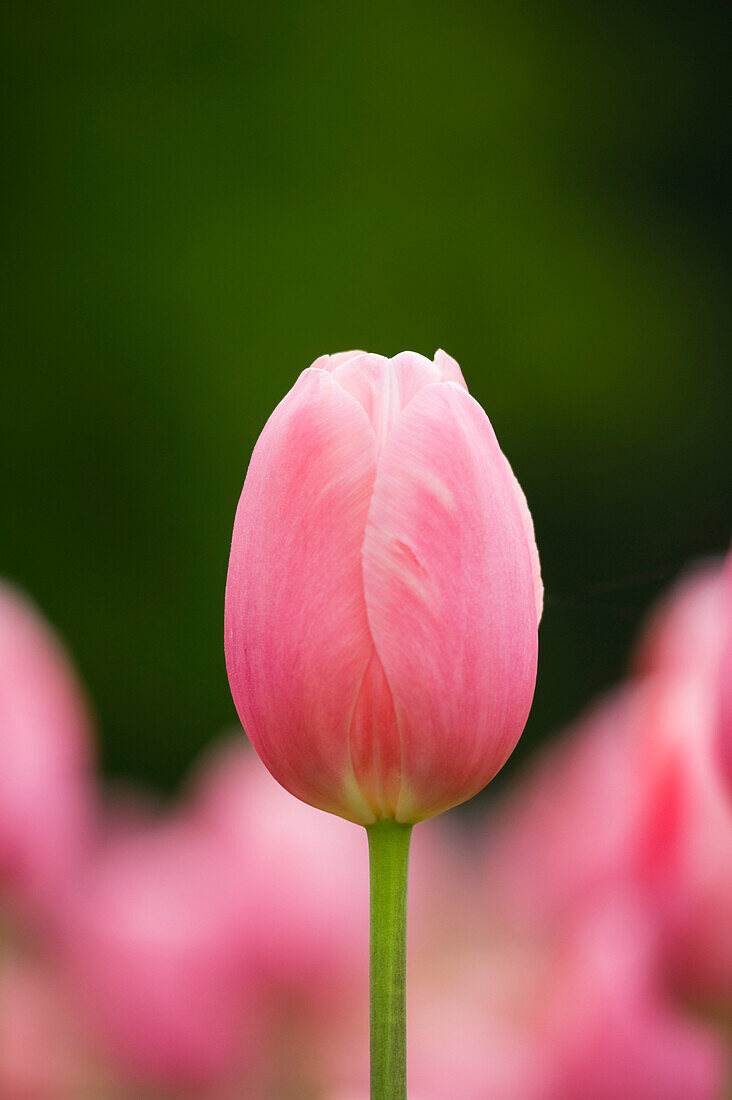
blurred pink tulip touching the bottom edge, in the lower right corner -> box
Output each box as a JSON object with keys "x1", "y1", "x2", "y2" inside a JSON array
[{"x1": 538, "y1": 898, "x2": 728, "y2": 1100}]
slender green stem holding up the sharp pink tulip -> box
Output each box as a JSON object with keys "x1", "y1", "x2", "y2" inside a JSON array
[{"x1": 367, "y1": 821, "x2": 412, "y2": 1100}]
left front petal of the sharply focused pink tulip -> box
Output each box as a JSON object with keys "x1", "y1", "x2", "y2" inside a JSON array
[{"x1": 226, "y1": 370, "x2": 376, "y2": 824}]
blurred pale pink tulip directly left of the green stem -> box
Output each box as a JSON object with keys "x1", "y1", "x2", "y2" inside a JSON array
[{"x1": 189, "y1": 734, "x2": 369, "y2": 1011}]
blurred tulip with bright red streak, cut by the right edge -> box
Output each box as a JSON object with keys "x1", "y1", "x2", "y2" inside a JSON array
[{"x1": 636, "y1": 675, "x2": 732, "y2": 1003}]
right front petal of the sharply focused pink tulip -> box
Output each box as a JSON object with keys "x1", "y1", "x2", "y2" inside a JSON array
[{"x1": 363, "y1": 383, "x2": 537, "y2": 821}]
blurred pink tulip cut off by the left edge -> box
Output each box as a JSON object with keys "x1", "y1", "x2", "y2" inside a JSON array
[{"x1": 0, "y1": 585, "x2": 92, "y2": 912}]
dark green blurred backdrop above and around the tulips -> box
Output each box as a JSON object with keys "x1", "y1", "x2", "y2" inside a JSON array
[{"x1": 0, "y1": 0, "x2": 732, "y2": 788}]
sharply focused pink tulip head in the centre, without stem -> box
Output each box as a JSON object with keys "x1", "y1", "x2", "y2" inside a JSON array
[{"x1": 226, "y1": 352, "x2": 542, "y2": 824}]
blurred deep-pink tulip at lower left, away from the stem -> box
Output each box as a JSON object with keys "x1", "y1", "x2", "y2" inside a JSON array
[{"x1": 64, "y1": 816, "x2": 255, "y2": 1090}]
